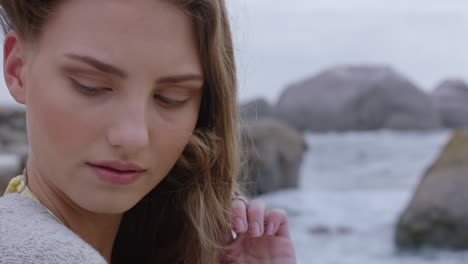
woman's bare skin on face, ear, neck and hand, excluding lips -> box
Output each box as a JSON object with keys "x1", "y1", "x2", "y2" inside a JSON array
[{"x1": 4, "y1": 0, "x2": 295, "y2": 264}]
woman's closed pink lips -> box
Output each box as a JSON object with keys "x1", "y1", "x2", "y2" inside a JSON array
[{"x1": 88, "y1": 163, "x2": 144, "y2": 185}]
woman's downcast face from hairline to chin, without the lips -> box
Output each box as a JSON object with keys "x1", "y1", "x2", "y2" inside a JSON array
[{"x1": 12, "y1": 0, "x2": 203, "y2": 213}]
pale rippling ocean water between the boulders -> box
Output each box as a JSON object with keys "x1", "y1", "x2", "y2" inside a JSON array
[{"x1": 263, "y1": 131, "x2": 468, "y2": 264}]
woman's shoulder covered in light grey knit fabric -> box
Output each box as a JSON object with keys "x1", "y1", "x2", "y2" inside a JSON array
[{"x1": 0, "y1": 194, "x2": 106, "y2": 264}]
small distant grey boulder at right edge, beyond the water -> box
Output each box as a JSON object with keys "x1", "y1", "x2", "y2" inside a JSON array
[{"x1": 431, "y1": 79, "x2": 468, "y2": 128}]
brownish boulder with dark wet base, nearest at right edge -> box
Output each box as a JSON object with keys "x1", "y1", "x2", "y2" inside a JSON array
[{"x1": 395, "y1": 130, "x2": 468, "y2": 249}]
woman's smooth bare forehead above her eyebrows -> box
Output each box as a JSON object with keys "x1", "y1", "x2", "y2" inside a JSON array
[{"x1": 33, "y1": 0, "x2": 200, "y2": 76}]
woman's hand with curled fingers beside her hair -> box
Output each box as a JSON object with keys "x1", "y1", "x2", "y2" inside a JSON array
[{"x1": 221, "y1": 199, "x2": 296, "y2": 264}]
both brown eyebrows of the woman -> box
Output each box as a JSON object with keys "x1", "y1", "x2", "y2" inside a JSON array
[{"x1": 65, "y1": 53, "x2": 204, "y2": 83}]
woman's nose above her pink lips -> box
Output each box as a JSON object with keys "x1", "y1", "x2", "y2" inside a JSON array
[{"x1": 108, "y1": 104, "x2": 149, "y2": 154}]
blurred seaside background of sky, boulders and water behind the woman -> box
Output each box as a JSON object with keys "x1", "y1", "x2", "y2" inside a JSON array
[{"x1": 0, "y1": 0, "x2": 468, "y2": 264}]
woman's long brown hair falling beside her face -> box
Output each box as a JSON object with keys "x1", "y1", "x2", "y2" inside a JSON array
[{"x1": 0, "y1": 0, "x2": 239, "y2": 264}]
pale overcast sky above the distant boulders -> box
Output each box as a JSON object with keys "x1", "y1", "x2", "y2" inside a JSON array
[{"x1": 0, "y1": 0, "x2": 468, "y2": 102}]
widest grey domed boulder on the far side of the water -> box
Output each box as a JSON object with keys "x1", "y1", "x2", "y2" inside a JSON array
[{"x1": 277, "y1": 66, "x2": 441, "y2": 131}]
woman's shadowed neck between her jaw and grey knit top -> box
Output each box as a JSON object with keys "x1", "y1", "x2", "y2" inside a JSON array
[{"x1": 27, "y1": 162, "x2": 123, "y2": 263}]
